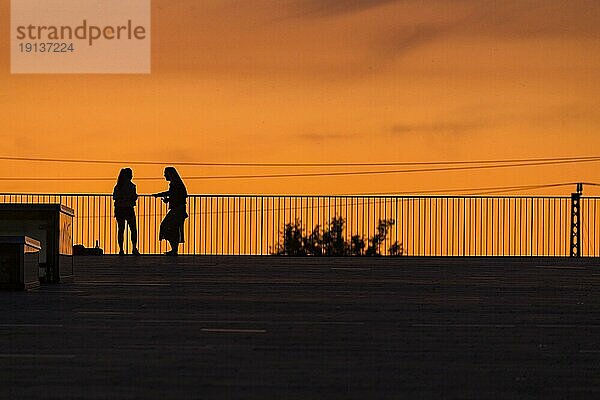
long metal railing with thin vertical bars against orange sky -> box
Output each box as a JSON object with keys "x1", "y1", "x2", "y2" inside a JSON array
[{"x1": 0, "y1": 193, "x2": 600, "y2": 257}]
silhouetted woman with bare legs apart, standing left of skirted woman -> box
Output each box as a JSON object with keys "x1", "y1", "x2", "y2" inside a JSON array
[{"x1": 113, "y1": 168, "x2": 140, "y2": 256}]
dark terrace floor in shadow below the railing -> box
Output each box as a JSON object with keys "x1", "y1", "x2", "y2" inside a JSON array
[{"x1": 0, "y1": 256, "x2": 600, "y2": 399}]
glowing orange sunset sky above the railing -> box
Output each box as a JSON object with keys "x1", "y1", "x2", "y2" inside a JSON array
[{"x1": 0, "y1": 0, "x2": 600, "y2": 194}]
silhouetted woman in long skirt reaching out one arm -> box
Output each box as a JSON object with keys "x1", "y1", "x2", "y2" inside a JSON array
[{"x1": 153, "y1": 167, "x2": 188, "y2": 256}]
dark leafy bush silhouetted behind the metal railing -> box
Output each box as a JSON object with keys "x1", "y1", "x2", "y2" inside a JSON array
[{"x1": 275, "y1": 217, "x2": 403, "y2": 257}]
